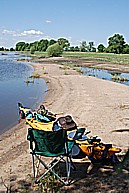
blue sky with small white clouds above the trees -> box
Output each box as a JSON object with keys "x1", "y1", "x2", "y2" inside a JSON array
[{"x1": 0, "y1": 0, "x2": 129, "y2": 48}]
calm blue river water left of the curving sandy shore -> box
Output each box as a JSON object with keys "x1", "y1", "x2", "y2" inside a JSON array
[{"x1": 0, "y1": 53, "x2": 47, "y2": 134}]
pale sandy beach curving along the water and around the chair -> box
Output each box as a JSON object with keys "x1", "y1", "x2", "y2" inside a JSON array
[{"x1": 0, "y1": 58, "x2": 129, "y2": 192}]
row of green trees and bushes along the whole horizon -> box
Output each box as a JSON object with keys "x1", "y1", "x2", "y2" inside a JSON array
[{"x1": 0, "y1": 34, "x2": 129, "y2": 56}]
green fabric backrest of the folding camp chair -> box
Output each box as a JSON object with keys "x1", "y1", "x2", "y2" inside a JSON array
[{"x1": 28, "y1": 128, "x2": 67, "y2": 156}]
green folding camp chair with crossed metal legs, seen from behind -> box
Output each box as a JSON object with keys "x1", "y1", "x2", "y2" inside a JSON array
[{"x1": 27, "y1": 128, "x2": 75, "y2": 185}]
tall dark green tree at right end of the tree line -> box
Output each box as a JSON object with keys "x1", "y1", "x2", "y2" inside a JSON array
[{"x1": 106, "y1": 34, "x2": 125, "y2": 54}]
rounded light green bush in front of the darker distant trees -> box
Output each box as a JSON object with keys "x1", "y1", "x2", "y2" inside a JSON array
[{"x1": 46, "y1": 43, "x2": 63, "y2": 57}]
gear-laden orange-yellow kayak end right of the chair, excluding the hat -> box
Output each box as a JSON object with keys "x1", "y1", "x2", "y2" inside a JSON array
[{"x1": 68, "y1": 128, "x2": 121, "y2": 165}]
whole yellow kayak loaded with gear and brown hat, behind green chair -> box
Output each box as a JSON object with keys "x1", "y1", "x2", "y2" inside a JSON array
[{"x1": 18, "y1": 103, "x2": 121, "y2": 164}]
